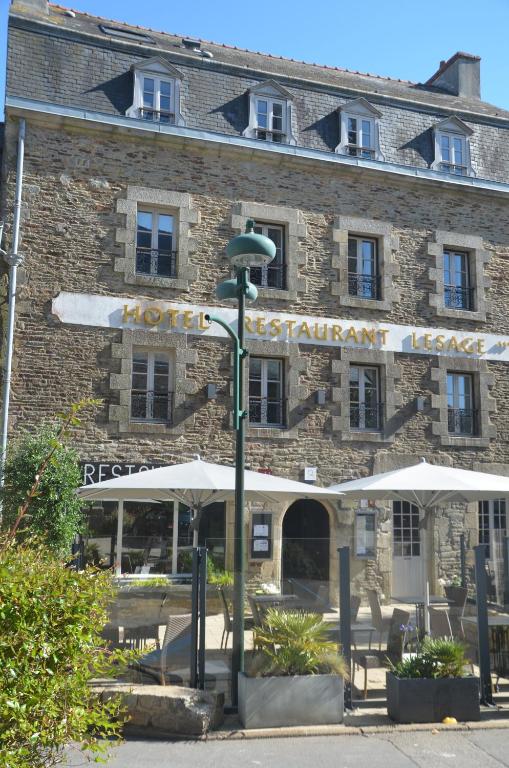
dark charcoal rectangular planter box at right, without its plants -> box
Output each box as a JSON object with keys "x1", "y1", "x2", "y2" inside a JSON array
[{"x1": 387, "y1": 672, "x2": 481, "y2": 723}]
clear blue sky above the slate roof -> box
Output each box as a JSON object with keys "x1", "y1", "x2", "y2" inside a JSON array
[{"x1": 0, "y1": 0, "x2": 509, "y2": 109}]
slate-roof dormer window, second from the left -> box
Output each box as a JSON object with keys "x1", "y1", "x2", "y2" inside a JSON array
[{"x1": 244, "y1": 80, "x2": 296, "y2": 144}]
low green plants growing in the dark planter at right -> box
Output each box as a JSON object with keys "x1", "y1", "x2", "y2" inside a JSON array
[{"x1": 392, "y1": 637, "x2": 468, "y2": 679}]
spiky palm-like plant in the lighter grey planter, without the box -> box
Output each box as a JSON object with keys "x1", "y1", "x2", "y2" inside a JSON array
[{"x1": 251, "y1": 608, "x2": 347, "y2": 677}]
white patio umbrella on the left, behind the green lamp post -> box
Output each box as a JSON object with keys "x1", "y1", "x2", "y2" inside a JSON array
[{"x1": 77, "y1": 459, "x2": 340, "y2": 570}]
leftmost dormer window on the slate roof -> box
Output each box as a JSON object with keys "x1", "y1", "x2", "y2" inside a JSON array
[{"x1": 126, "y1": 58, "x2": 185, "y2": 125}]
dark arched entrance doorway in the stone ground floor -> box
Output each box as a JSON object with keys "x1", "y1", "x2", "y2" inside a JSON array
[{"x1": 281, "y1": 499, "x2": 330, "y2": 596}]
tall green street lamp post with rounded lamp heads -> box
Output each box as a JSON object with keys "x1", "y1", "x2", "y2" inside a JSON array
[{"x1": 205, "y1": 220, "x2": 276, "y2": 707}]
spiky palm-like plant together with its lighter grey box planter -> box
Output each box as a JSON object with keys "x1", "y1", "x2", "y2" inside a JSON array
[{"x1": 238, "y1": 608, "x2": 347, "y2": 728}]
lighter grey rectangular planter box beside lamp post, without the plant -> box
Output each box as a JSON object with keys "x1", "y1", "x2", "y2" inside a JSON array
[{"x1": 239, "y1": 673, "x2": 344, "y2": 728}]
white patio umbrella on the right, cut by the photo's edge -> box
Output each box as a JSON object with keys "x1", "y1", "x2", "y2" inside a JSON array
[{"x1": 329, "y1": 459, "x2": 509, "y2": 630}]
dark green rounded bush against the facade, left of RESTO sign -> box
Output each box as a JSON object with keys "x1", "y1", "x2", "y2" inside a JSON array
[{"x1": 0, "y1": 423, "x2": 82, "y2": 554}]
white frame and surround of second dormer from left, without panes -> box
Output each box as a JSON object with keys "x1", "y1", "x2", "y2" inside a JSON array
[{"x1": 243, "y1": 80, "x2": 297, "y2": 145}]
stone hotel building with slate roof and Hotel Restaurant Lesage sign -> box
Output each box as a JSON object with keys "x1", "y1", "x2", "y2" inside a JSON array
[{"x1": 2, "y1": 0, "x2": 509, "y2": 596}]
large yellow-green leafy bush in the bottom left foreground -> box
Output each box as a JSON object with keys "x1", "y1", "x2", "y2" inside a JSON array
[{"x1": 0, "y1": 541, "x2": 131, "y2": 768}]
